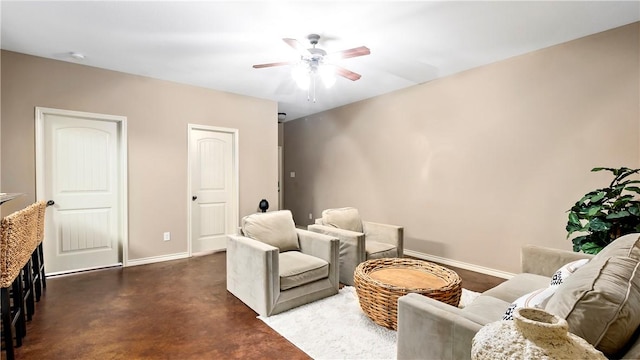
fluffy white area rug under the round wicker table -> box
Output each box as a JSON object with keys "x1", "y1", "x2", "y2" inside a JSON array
[{"x1": 258, "y1": 286, "x2": 479, "y2": 360}]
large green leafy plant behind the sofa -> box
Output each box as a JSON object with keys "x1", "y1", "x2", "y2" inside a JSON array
[{"x1": 566, "y1": 167, "x2": 640, "y2": 254}]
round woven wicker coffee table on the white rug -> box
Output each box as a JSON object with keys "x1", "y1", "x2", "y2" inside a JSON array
[{"x1": 354, "y1": 258, "x2": 462, "y2": 330}]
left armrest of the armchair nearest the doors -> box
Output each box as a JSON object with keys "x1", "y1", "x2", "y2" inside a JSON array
[{"x1": 227, "y1": 235, "x2": 280, "y2": 315}]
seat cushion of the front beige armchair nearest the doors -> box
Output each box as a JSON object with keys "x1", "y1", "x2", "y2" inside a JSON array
[{"x1": 278, "y1": 251, "x2": 329, "y2": 290}]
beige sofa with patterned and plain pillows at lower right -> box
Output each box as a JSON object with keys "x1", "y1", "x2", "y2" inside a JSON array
[{"x1": 397, "y1": 234, "x2": 640, "y2": 360}]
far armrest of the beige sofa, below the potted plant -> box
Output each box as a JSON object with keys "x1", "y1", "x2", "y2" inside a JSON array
[{"x1": 520, "y1": 245, "x2": 593, "y2": 277}]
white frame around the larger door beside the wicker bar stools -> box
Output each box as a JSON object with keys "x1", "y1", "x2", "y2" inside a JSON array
[{"x1": 35, "y1": 106, "x2": 129, "y2": 267}]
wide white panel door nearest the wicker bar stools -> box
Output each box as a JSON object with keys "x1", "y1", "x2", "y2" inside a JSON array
[{"x1": 38, "y1": 113, "x2": 122, "y2": 273}]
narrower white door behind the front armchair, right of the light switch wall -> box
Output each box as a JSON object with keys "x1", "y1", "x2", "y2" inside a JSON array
[{"x1": 189, "y1": 129, "x2": 237, "y2": 253}]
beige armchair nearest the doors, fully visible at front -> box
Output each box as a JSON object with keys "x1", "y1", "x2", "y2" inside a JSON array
[{"x1": 227, "y1": 210, "x2": 339, "y2": 316}]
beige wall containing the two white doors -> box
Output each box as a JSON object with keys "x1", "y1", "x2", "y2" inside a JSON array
[{"x1": 1, "y1": 51, "x2": 278, "y2": 259}]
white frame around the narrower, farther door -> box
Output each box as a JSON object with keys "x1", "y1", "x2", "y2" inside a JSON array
[{"x1": 187, "y1": 124, "x2": 240, "y2": 257}]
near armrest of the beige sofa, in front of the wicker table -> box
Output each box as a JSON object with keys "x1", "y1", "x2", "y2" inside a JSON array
[{"x1": 397, "y1": 294, "x2": 484, "y2": 360}]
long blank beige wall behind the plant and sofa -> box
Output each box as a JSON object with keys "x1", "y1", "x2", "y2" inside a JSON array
[{"x1": 284, "y1": 23, "x2": 640, "y2": 272}]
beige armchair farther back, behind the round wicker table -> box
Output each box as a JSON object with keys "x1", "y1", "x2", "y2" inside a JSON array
[{"x1": 307, "y1": 207, "x2": 404, "y2": 285}]
